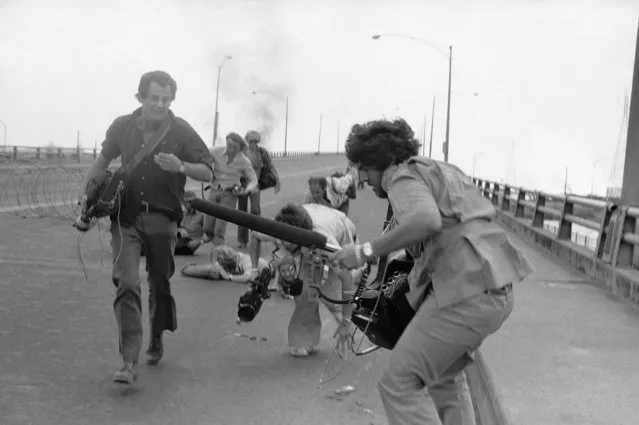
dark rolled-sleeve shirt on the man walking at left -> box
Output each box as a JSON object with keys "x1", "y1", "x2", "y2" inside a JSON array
[{"x1": 101, "y1": 108, "x2": 212, "y2": 225}]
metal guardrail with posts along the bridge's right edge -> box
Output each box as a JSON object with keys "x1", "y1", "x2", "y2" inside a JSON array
[{"x1": 473, "y1": 178, "x2": 639, "y2": 269}]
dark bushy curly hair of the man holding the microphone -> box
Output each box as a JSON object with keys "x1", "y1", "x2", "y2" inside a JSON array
[{"x1": 346, "y1": 118, "x2": 421, "y2": 170}]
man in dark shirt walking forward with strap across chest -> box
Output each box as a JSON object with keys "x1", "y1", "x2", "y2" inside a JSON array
[{"x1": 77, "y1": 71, "x2": 213, "y2": 384}]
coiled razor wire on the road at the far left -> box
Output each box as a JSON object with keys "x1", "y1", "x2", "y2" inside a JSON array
[{"x1": 0, "y1": 165, "x2": 88, "y2": 220}]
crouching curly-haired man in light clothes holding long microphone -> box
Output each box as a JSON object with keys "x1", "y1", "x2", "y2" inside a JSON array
[{"x1": 334, "y1": 119, "x2": 532, "y2": 425}]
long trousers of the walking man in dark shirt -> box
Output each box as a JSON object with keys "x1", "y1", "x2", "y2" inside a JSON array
[{"x1": 111, "y1": 213, "x2": 177, "y2": 363}]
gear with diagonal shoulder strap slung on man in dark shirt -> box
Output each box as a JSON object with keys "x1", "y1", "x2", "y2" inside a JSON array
[{"x1": 82, "y1": 116, "x2": 173, "y2": 222}]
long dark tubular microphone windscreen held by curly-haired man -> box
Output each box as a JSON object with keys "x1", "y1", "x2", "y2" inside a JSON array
[{"x1": 189, "y1": 198, "x2": 327, "y2": 249}]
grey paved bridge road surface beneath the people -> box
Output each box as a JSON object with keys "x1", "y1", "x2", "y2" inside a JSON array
[{"x1": 0, "y1": 154, "x2": 639, "y2": 425}]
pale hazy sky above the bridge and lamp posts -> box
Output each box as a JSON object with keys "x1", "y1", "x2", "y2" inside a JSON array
[{"x1": 0, "y1": 0, "x2": 639, "y2": 192}]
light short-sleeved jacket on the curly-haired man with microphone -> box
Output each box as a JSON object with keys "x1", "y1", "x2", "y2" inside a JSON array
[{"x1": 382, "y1": 157, "x2": 532, "y2": 308}]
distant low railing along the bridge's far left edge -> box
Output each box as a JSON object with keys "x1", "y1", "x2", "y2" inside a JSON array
[{"x1": 0, "y1": 146, "x2": 324, "y2": 165}]
